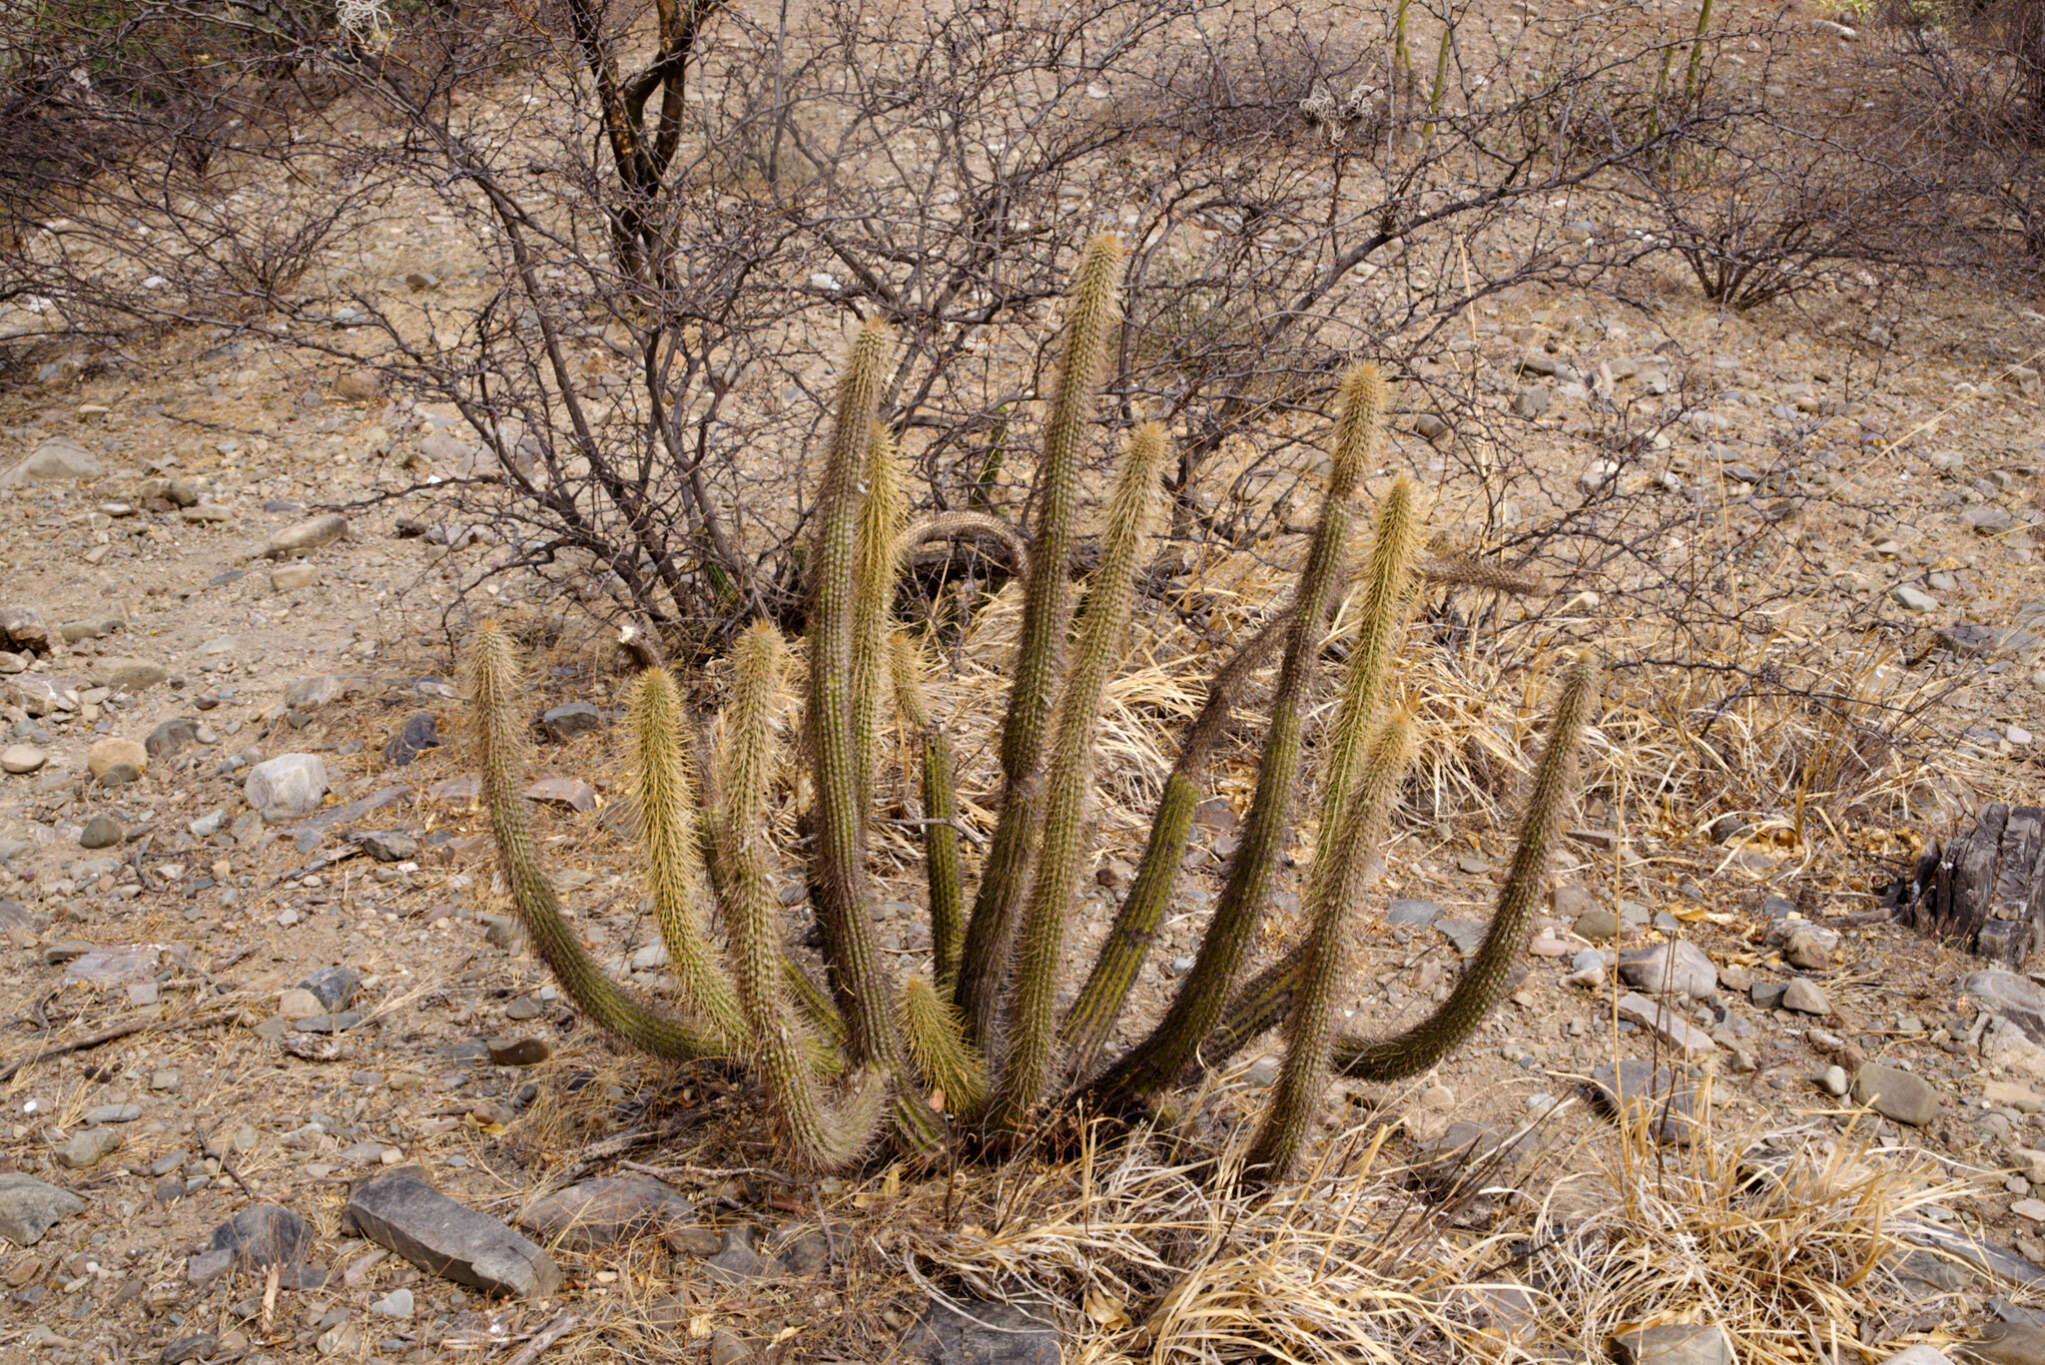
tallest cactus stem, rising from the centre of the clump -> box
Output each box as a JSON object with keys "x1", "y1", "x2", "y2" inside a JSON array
[{"x1": 955, "y1": 233, "x2": 1125, "y2": 1046}]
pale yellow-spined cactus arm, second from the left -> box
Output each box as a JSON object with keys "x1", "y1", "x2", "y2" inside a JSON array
[{"x1": 626, "y1": 669, "x2": 751, "y2": 1052}]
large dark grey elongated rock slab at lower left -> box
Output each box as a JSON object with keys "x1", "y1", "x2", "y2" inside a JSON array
[{"x1": 342, "y1": 1173, "x2": 560, "y2": 1300}]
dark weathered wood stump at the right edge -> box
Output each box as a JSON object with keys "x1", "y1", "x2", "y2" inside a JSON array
[{"x1": 1908, "y1": 800, "x2": 2045, "y2": 970}]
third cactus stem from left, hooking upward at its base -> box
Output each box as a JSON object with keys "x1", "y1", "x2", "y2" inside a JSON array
[{"x1": 720, "y1": 622, "x2": 888, "y2": 1171}]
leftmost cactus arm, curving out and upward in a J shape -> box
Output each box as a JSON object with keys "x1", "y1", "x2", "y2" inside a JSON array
[{"x1": 464, "y1": 622, "x2": 730, "y2": 1060}]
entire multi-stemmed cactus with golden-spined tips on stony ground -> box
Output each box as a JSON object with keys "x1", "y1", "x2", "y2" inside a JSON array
[{"x1": 468, "y1": 235, "x2": 1595, "y2": 1181}]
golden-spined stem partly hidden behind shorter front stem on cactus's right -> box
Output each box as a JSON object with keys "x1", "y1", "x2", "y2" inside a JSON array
[{"x1": 1307, "y1": 475, "x2": 1417, "y2": 905}]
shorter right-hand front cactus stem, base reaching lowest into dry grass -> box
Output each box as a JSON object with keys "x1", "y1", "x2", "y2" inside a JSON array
[{"x1": 1243, "y1": 718, "x2": 1413, "y2": 1181}]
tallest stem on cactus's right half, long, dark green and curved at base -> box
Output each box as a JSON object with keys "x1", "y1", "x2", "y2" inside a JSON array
[{"x1": 1090, "y1": 366, "x2": 1364, "y2": 1105}]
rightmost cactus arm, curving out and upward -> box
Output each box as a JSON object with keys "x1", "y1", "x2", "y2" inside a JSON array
[{"x1": 1335, "y1": 659, "x2": 1597, "y2": 1081}]
